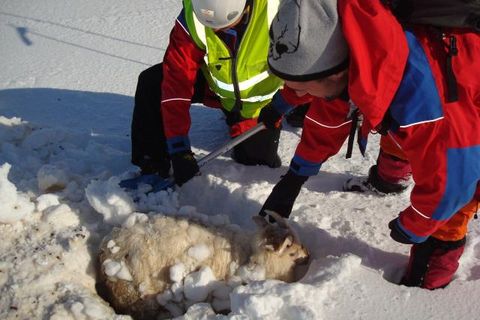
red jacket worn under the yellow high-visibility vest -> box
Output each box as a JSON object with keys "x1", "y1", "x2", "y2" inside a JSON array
[{"x1": 161, "y1": 10, "x2": 291, "y2": 153}]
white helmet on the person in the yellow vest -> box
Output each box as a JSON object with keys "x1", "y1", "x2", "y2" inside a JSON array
[{"x1": 192, "y1": 0, "x2": 247, "y2": 29}]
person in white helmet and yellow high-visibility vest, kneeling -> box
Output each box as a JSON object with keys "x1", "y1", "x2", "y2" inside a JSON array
[{"x1": 126, "y1": 0, "x2": 290, "y2": 187}]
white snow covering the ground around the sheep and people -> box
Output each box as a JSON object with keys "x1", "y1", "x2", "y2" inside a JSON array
[{"x1": 0, "y1": 0, "x2": 480, "y2": 320}]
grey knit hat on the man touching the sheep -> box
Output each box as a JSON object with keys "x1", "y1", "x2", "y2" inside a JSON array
[{"x1": 268, "y1": 0, "x2": 348, "y2": 81}]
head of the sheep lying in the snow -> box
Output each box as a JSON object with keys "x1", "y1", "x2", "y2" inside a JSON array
[{"x1": 250, "y1": 211, "x2": 309, "y2": 282}]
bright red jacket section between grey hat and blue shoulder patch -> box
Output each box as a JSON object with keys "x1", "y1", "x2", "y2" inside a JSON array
[{"x1": 338, "y1": 0, "x2": 409, "y2": 128}]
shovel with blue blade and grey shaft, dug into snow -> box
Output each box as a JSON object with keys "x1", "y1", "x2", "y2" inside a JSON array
[{"x1": 119, "y1": 122, "x2": 265, "y2": 193}]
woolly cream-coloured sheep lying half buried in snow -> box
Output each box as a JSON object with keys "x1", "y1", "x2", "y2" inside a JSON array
[{"x1": 98, "y1": 213, "x2": 309, "y2": 319}]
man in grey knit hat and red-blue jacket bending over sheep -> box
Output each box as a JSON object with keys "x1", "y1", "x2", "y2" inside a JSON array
[{"x1": 260, "y1": 0, "x2": 480, "y2": 289}]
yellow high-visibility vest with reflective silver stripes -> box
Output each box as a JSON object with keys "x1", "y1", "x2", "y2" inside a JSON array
[{"x1": 183, "y1": 0, "x2": 282, "y2": 118}]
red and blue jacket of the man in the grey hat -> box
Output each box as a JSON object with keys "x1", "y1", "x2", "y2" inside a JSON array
[{"x1": 287, "y1": 0, "x2": 480, "y2": 242}]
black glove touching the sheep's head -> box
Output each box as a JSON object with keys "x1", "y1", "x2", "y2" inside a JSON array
[{"x1": 259, "y1": 170, "x2": 308, "y2": 222}]
